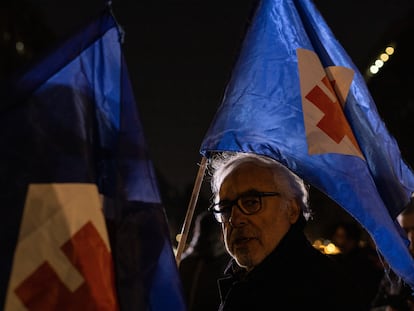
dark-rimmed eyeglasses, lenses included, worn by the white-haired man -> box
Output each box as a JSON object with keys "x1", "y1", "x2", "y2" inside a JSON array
[{"x1": 208, "y1": 192, "x2": 280, "y2": 223}]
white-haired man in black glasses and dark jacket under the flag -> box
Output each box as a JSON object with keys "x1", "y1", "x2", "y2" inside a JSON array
[{"x1": 209, "y1": 153, "x2": 363, "y2": 311}]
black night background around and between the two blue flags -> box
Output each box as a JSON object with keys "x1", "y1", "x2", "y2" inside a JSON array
[{"x1": 0, "y1": 0, "x2": 414, "y2": 243}]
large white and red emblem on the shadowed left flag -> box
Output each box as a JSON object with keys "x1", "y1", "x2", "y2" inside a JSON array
[{"x1": 5, "y1": 184, "x2": 119, "y2": 311}]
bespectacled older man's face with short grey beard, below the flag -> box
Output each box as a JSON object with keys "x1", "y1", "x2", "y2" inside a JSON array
[{"x1": 219, "y1": 163, "x2": 300, "y2": 270}]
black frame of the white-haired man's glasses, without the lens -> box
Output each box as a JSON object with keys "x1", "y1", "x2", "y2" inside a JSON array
[{"x1": 208, "y1": 191, "x2": 281, "y2": 223}]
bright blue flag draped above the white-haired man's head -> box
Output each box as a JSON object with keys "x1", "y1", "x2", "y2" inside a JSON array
[{"x1": 200, "y1": 0, "x2": 414, "y2": 287}]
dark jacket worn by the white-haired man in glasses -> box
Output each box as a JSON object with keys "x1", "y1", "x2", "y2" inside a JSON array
[{"x1": 218, "y1": 226, "x2": 364, "y2": 311}]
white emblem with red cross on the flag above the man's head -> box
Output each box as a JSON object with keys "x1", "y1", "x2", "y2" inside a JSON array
[{"x1": 296, "y1": 49, "x2": 364, "y2": 158}]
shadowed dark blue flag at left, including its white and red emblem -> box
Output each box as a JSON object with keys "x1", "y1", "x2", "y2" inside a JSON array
[{"x1": 0, "y1": 10, "x2": 185, "y2": 311}]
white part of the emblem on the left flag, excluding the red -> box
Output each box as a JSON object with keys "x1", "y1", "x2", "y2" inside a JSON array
[{"x1": 5, "y1": 183, "x2": 110, "y2": 310}]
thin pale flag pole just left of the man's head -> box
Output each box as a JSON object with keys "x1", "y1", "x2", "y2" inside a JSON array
[{"x1": 175, "y1": 157, "x2": 207, "y2": 267}]
